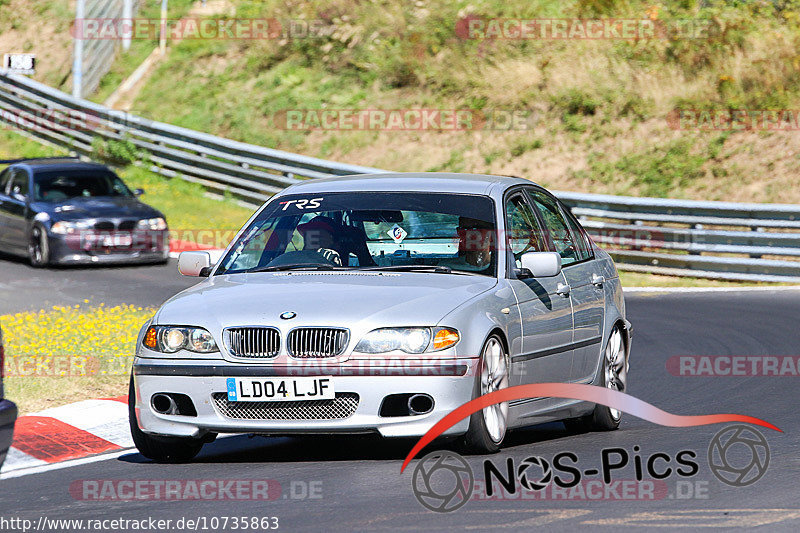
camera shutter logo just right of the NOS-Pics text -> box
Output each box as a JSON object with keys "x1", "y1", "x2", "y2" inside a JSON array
[{"x1": 708, "y1": 424, "x2": 769, "y2": 487}]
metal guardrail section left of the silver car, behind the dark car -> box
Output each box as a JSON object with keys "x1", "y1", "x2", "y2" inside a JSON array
[{"x1": 0, "y1": 71, "x2": 382, "y2": 204}]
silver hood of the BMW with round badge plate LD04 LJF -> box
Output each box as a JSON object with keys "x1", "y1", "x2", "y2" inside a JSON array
[{"x1": 154, "y1": 272, "x2": 497, "y2": 331}]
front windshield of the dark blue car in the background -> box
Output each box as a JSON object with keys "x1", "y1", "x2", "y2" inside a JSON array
[{"x1": 33, "y1": 170, "x2": 132, "y2": 202}]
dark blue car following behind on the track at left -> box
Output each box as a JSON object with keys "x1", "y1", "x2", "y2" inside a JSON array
[{"x1": 0, "y1": 158, "x2": 169, "y2": 267}]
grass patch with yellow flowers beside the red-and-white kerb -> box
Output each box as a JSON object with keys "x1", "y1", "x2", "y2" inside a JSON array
[{"x1": 0, "y1": 304, "x2": 155, "y2": 414}]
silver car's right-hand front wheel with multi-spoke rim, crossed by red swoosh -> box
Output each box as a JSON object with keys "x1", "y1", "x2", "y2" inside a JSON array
[{"x1": 464, "y1": 335, "x2": 508, "y2": 453}]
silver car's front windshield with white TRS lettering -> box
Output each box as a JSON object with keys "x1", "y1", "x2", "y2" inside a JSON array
[{"x1": 217, "y1": 192, "x2": 497, "y2": 276}]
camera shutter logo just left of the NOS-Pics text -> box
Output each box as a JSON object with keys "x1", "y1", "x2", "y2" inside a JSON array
[{"x1": 411, "y1": 450, "x2": 475, "y2": 513}]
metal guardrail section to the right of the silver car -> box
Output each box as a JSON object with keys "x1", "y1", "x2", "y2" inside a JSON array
[{"x1": 555, "y1": 191, "x2": 800, "y2": 282}]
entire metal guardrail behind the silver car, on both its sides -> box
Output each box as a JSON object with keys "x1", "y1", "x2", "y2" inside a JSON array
[{"x1": 0, "y1": 71, "x2": 800, "y2": 282}]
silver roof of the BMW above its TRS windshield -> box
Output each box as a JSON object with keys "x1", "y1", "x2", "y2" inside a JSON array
[{"x1": 285, "y1": 172, "x2": 533, "y2": 195}]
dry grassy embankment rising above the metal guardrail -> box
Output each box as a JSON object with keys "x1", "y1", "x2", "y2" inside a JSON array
[{"x1": 117, "y1": 0, "x2": 800, "y2": 202}]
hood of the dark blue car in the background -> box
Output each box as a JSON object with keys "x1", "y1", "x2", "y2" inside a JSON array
[{"x1": 36, "y1": 196, "x2": 163, "y2": 220}]
